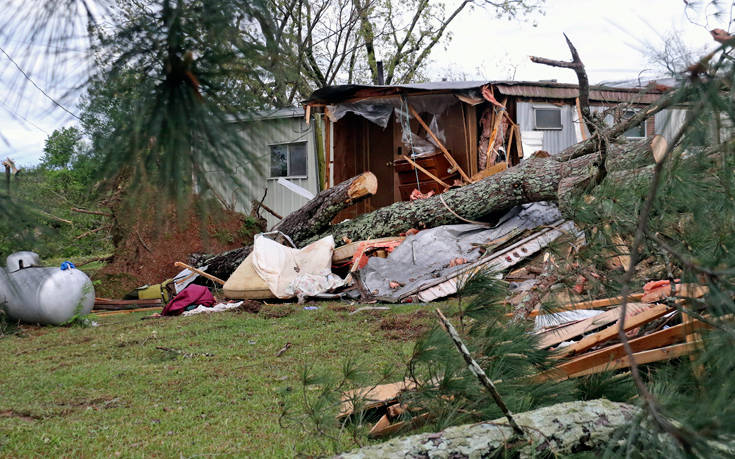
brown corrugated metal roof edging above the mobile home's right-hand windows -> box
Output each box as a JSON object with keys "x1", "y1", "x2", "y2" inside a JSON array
[{"x1": 495, "y1": 84, "x2": 661, "y2": 104}]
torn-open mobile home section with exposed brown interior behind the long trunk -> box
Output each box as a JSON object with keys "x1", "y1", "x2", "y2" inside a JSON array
[{"x1": 305, "y1": 81, "x2": 685, "y2": 218}]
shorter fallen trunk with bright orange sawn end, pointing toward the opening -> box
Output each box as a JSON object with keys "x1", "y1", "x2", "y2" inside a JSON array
[{"x1": 189, "y1": 172, "x2": 378, "y2": 279}]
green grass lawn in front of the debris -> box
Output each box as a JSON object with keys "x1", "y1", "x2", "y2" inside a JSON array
[{"x1": 0, "y1": 303, "x2": 433, "y2": 457}]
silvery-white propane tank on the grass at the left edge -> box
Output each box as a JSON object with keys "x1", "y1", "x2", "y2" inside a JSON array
[{"x1": 0, "y1": 252, "x2": 95, "y2": 325}]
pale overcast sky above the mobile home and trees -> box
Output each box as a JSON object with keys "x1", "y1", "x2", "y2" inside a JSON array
[{"x1": 0, "y1": 0, "x2": 730, "y2": 165}]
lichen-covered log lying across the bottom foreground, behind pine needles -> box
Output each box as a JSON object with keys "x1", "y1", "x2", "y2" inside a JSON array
[{"x1": 337, "y1": 399, "x2": 639, "y2": 459}]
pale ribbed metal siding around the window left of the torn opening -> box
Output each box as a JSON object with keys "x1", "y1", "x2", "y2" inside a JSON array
[{"x1": 205, "y1": 117, "x2": 319, "y2": 228}]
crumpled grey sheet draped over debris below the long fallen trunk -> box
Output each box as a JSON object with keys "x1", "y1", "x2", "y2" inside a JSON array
[{"x1": 359, "y1": 202, "x2": 562, "y2": 302}]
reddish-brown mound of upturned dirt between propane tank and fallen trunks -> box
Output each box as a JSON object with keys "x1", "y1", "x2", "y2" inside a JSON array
[{"x1": 94, "y1": 203, "x2": 258, "y2": 298}]
